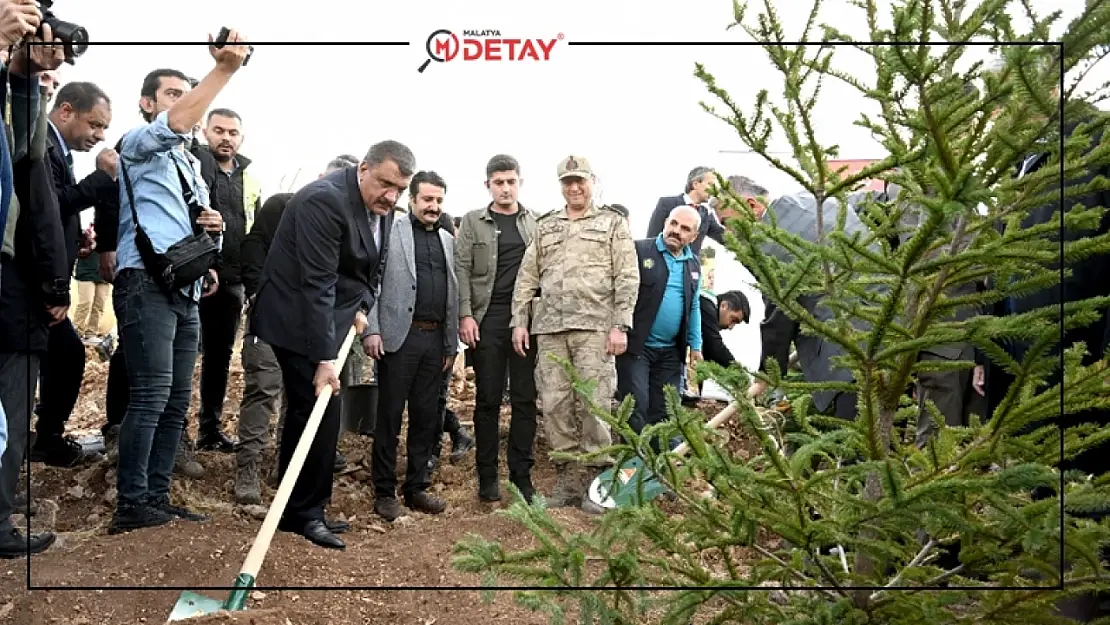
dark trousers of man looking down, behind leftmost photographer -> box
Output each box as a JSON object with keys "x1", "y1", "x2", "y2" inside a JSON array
[{"x1": 34, "y1": 317, "x2": 84, "y2": 436}]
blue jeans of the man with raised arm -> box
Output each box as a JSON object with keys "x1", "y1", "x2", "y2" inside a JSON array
[{"x1": 113, "y1": 270, "x2": 201, "y2": 508}]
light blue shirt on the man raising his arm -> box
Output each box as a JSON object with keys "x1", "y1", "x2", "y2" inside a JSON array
[{"x1": 115, "y1": 112, "x2": 209, "y2": 301}]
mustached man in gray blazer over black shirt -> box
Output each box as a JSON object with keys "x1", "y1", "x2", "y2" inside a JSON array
[{"x1": 366, "y1": 171, "x2": 458, "y2": 522}]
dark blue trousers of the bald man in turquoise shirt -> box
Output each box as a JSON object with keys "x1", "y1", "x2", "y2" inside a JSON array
[{"x1": 617, "y1": 346, "x2": 685, "y2": 451}]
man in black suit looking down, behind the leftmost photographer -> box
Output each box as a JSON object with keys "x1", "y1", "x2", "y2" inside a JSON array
[{"x1": 31, "y1": 82, "x2": 119, "y2": 466}]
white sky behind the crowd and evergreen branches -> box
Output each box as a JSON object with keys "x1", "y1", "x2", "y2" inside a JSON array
[{"x1": 53, "y1": 0, "x2": 1110, "y2": 366}]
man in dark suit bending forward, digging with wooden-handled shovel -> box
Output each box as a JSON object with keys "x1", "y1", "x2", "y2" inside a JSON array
[{"x1": 250, "y1": 141, "x2": 416, "y2": 550}]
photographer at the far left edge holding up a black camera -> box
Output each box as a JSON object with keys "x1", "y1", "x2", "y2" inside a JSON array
[{"x1": 0, "y1": 6, "x2": 69, "y2": 558}]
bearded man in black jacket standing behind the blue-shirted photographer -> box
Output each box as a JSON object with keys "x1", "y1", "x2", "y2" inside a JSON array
[{"x1": 191, "y1": 109, "x2": 262, "y2": 453}]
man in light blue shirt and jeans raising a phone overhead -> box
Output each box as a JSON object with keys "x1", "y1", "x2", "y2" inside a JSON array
[{"x1": 109, "y1": 31, "x2": 249, "y2": 534}]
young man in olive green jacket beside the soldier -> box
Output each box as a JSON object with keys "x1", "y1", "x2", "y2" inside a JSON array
[{"x1": 455, "y1": 154, "x2": 536, "y2": 502}]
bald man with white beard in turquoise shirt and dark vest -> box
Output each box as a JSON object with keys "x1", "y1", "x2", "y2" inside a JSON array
[{"x1": 617, "y1": 205, "x2": 702, "y2": 451}]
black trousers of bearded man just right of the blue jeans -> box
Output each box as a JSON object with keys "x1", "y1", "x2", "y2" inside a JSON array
[{"x1": 199, "y1": 284, "x2": 243, "y2": 435}]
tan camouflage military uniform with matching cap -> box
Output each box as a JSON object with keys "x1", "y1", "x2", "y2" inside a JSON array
[{"x1": 512, "y1": 157, "x2": 639, "y2": 507}]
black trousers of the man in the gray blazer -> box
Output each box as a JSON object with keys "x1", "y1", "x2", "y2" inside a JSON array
[{"x1": 371, "y1": 326, "x2": 445, "y2": 497}]
